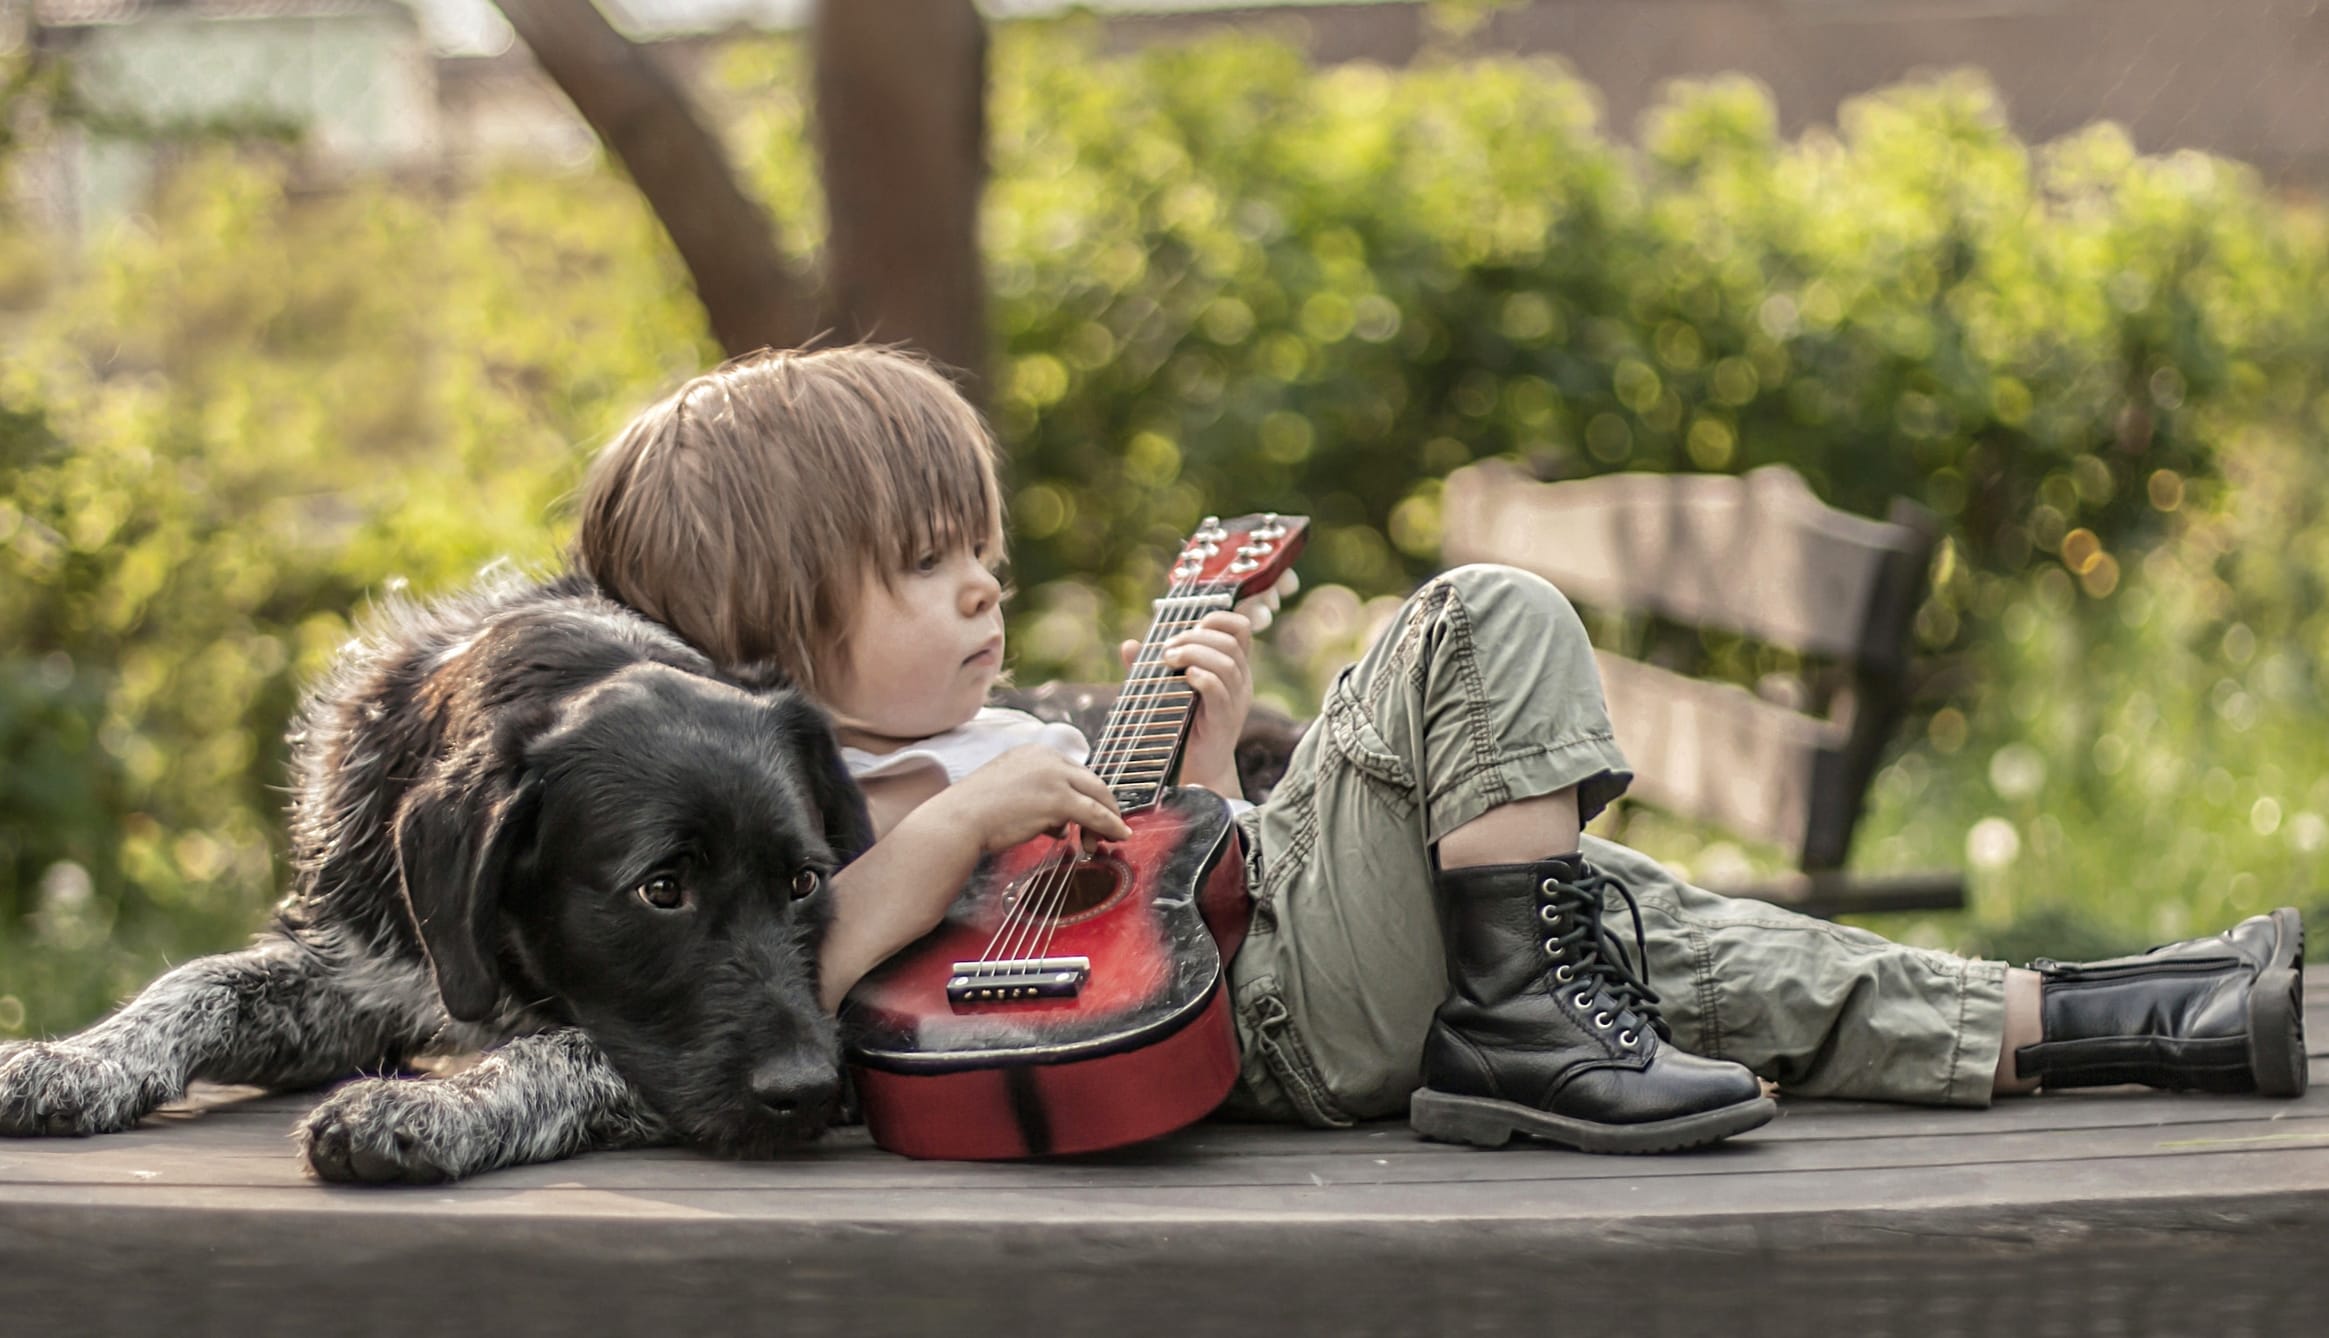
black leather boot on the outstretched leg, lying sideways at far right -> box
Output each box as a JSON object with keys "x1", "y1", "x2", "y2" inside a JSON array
[{"x1": 2015, "y1": 907, "x2": 2306, "y2": 1096}]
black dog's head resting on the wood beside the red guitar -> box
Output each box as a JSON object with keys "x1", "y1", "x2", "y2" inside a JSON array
[{"x1": 396, "y1": 664, "x2": 873, "y2": 1156}]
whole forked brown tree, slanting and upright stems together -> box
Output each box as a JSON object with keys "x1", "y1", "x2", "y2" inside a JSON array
[{"x1": 496, "y1": 0, "x2": 985, "y2": 392}]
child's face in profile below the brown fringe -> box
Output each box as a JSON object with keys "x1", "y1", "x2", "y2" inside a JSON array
[{"x1": 824, "y1": 543, "x2": 1004, "y2": 748}]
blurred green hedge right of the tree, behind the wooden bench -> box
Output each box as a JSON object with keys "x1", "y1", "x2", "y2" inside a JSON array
[{"x1": 959, "y1": 37, "x2": 2329, "y2": 680}]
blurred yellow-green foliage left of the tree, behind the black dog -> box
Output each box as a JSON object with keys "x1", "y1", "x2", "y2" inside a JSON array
[{"x1": 0, "y1": 152, "x2": 713, "y2": 1030}]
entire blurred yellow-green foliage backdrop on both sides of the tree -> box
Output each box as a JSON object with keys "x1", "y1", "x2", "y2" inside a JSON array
[{"x1": 0, "y1": 26, "x2": 2329, "y2": 1033}]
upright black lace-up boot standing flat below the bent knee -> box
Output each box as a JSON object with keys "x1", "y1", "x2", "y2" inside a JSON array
[{"x1": 1407, "y1": 855, "x2": 1779, "y2": 1152}]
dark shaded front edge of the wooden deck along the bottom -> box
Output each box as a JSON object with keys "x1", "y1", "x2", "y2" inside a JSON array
[{"x1": 0, "y1": 1177, "x2": 2324, "y2": 1338}]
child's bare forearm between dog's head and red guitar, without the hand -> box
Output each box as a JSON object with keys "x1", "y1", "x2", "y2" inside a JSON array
[{"x1": 817, "y1": 804, "x2": 981, "y2": 1012}]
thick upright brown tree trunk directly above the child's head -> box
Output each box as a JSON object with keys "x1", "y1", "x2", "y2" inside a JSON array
[{"x1": 815, "y1": 0, "x2": 987, "y2": 399}]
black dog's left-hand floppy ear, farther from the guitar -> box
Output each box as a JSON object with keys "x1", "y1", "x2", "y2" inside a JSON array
[{"x1": 396, "y1": 765, "x2": 543, "y2": 1021}]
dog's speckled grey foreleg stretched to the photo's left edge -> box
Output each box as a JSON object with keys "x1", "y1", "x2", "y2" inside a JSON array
[{"x1": 0, "y1": 935, "x2": 424, "y2": 1135}]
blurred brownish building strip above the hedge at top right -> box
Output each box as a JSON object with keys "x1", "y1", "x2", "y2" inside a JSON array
[{"x1": 1094, "y1": 0, "x2": 2329, "y2": 189}]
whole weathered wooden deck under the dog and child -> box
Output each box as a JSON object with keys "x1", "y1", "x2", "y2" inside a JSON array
[{"x1": 0, "y1": 1005, "x2": 2329, "y2": 1338}]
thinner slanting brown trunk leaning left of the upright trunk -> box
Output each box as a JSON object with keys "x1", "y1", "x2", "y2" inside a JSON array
[{"x1": 494, "y1": 0, "x2": 815, "y2": 357}]
